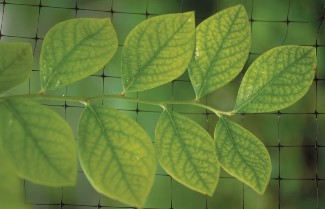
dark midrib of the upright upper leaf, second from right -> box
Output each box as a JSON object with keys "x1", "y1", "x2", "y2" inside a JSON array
[{"x1": 197, "y1": 7, "x2": 240, "y2": 98}]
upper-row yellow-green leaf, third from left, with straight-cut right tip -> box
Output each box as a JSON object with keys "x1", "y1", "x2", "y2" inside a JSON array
[{"x1": 122, "y1": 12, "x2": 195, "y2": 92}]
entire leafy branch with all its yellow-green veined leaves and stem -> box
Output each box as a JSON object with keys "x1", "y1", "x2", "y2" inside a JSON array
[{"x1": 0, "y1": 5, "x2": 316, "y2": 207}]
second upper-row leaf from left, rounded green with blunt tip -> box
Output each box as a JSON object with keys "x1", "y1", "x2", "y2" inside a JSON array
[{"x1": 40, "y1": 18, "x2": 117, "y2": 92}]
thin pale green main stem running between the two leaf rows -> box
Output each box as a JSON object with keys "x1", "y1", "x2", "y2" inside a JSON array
[{"x1": 0, "y1": 93, "x2": 233, "y2": 117}]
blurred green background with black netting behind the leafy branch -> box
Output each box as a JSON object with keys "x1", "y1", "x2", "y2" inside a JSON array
[{"x1": 0, "y1": 0, "x2": 325, "y2": 209}]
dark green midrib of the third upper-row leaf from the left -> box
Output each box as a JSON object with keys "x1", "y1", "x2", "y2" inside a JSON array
[{"x1": 125, "y1": 13, "x2": 191, "y2": 91}]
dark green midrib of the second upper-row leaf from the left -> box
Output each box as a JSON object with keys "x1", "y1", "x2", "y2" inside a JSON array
[{"x1": 43, "y1": 19, "x2": 109, "y2": 90}]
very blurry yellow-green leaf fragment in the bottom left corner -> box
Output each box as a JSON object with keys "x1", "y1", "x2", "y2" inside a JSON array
[{"x1": 0, "y1": 147, "x2": 31, "y2": 209}]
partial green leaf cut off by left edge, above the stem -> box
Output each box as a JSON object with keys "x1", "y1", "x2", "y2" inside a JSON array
[{"x1": 0, "y1": 42, "x2": 33, "y2": 94}]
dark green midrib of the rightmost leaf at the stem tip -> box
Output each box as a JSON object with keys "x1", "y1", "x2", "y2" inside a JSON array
[{"x1": 234, "y1": 48, "x2": 310, "y2": 112}]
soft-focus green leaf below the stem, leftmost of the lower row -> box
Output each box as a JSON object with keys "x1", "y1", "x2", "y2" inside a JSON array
[{"x1": 0, "y1": 99, "x2": 77, "y2": 186}]
